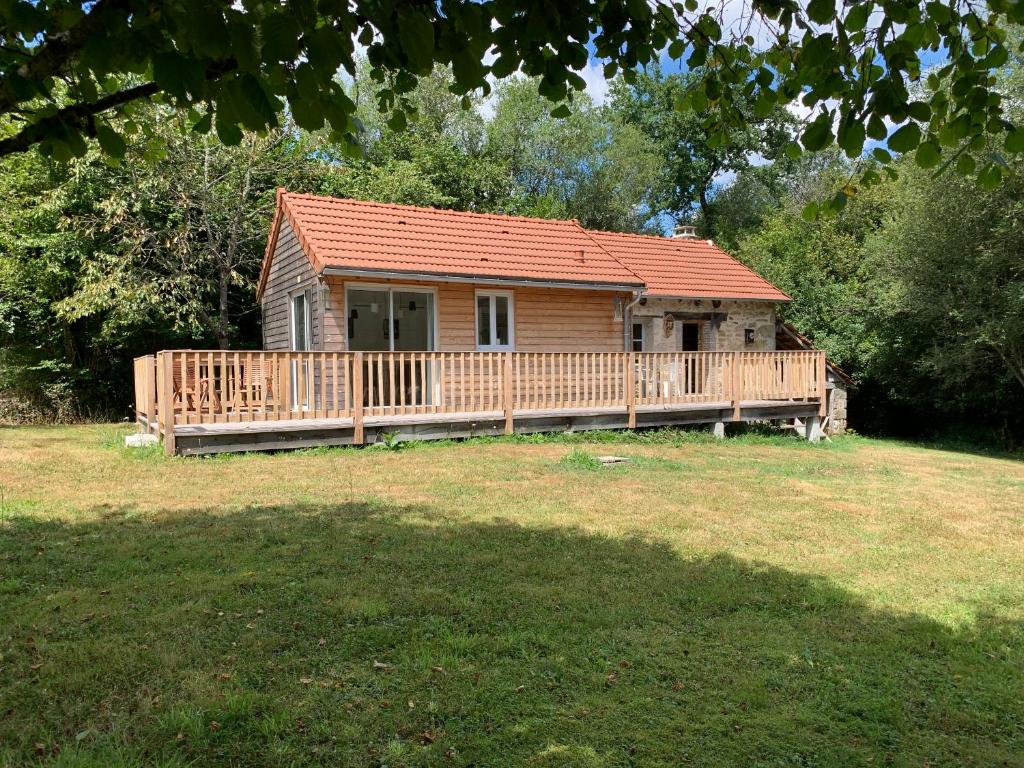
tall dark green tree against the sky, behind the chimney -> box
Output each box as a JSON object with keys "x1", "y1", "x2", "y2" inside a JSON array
[{"x1": 611, "y1": 66, "x2": 795, "y2": 237}]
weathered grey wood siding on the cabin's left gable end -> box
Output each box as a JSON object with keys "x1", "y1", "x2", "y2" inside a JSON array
[{"x1": 261, "y1": 219, "x2": 324, "y2": 351}]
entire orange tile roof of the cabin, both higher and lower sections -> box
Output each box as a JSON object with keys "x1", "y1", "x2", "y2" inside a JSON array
[{"x1": 258, "y1": 189, "x2": 788, "y2": 301}]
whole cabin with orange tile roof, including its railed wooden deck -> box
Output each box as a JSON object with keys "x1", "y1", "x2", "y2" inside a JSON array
[{"x1": 136, "y1": 189, "x2": 825, "y2": 453}]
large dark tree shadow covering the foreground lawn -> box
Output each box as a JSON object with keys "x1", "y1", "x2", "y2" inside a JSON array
[{"x1": 0, "y1": 505, "x2": 1024, "y2": 766}]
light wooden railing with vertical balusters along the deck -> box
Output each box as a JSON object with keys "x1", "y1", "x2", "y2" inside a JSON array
[{"x1": 134, "y1": 350, "x2": 825, "y2": 454}]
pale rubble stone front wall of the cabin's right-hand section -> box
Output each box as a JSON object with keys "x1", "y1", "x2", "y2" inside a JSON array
[{"x1": 632, "y1": 298, "x2": 775, "y2": 352}]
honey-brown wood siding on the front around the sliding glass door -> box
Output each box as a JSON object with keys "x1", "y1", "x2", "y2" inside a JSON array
[{"x1": 317, "y1": 276, "x2": 630, "y2": 352}]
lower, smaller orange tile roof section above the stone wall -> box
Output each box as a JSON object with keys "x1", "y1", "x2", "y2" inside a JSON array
[{"x1": 591, "y1": 231, "x2": 790, "y2": 301}]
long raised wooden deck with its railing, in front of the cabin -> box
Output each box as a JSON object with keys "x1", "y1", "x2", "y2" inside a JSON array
[{"x1": 135, "y1": 350, "x2": 825, "y2": 455}]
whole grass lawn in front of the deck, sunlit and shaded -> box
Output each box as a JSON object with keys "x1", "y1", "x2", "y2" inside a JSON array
[{"x1": 0, "y1": 426, "x2": 1024, "y2": 768}]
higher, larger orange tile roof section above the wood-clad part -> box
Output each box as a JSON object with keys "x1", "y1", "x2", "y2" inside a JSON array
[{"x1": 266, "y1": 193, "x2": 643, "y2": 288}]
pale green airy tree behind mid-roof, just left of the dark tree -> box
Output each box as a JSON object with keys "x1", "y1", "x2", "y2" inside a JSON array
[{"x1": 487, "y1": 78, "x2": 662, "y2": 231}]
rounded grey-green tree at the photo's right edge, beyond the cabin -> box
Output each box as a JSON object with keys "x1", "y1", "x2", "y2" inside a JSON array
[{"x1": 869, "y1": 165, "x2": 1024, "y2": 404}]
